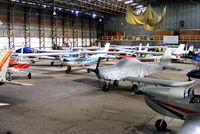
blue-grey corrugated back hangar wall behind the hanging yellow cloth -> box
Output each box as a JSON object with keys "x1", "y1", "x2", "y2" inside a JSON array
[{"x1": 104, "y1": 0, "x2": 200, "y2": 43}]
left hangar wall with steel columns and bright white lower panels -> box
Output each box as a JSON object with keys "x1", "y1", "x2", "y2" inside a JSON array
[{"x1": 0, "y1": 2, "x2": 102, "y2": 49}]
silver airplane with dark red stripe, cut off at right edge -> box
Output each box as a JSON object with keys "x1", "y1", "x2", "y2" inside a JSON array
[{"x1": 140, "y1": 83, "x2": 200, "y2": 134}]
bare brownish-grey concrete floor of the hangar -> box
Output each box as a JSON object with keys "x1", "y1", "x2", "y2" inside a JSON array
[{"x1": 0, "y1": 60, "x2": 198, "y2": 134}]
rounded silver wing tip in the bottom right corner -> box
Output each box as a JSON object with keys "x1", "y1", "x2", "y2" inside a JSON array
[{"x1": 177, "y1": 116, "x2": 200, "y2": 134}]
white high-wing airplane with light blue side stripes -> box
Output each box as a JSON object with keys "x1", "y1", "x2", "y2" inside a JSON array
[{"x1": 15, "y1": 43, "x2": 119, "y2": 73}]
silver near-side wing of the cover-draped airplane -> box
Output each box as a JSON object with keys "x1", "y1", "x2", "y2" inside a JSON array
[{"x1": 124, "y1": 76, "x2": 196, "y2": 87}]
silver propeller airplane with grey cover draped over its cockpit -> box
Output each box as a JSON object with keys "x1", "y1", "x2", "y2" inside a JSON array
[{"x1": 87, "y1": 48, "x2": 195, "y2": 92}]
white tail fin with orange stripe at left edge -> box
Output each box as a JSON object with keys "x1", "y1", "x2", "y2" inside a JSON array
[{"x1": 0, "y1": 50, "x2": 12, "y2": 81}]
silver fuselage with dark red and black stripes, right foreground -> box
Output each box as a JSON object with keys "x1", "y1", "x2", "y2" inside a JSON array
[{"x1": 144, "y1": 87, "x2": 200, "y2": 120}]
